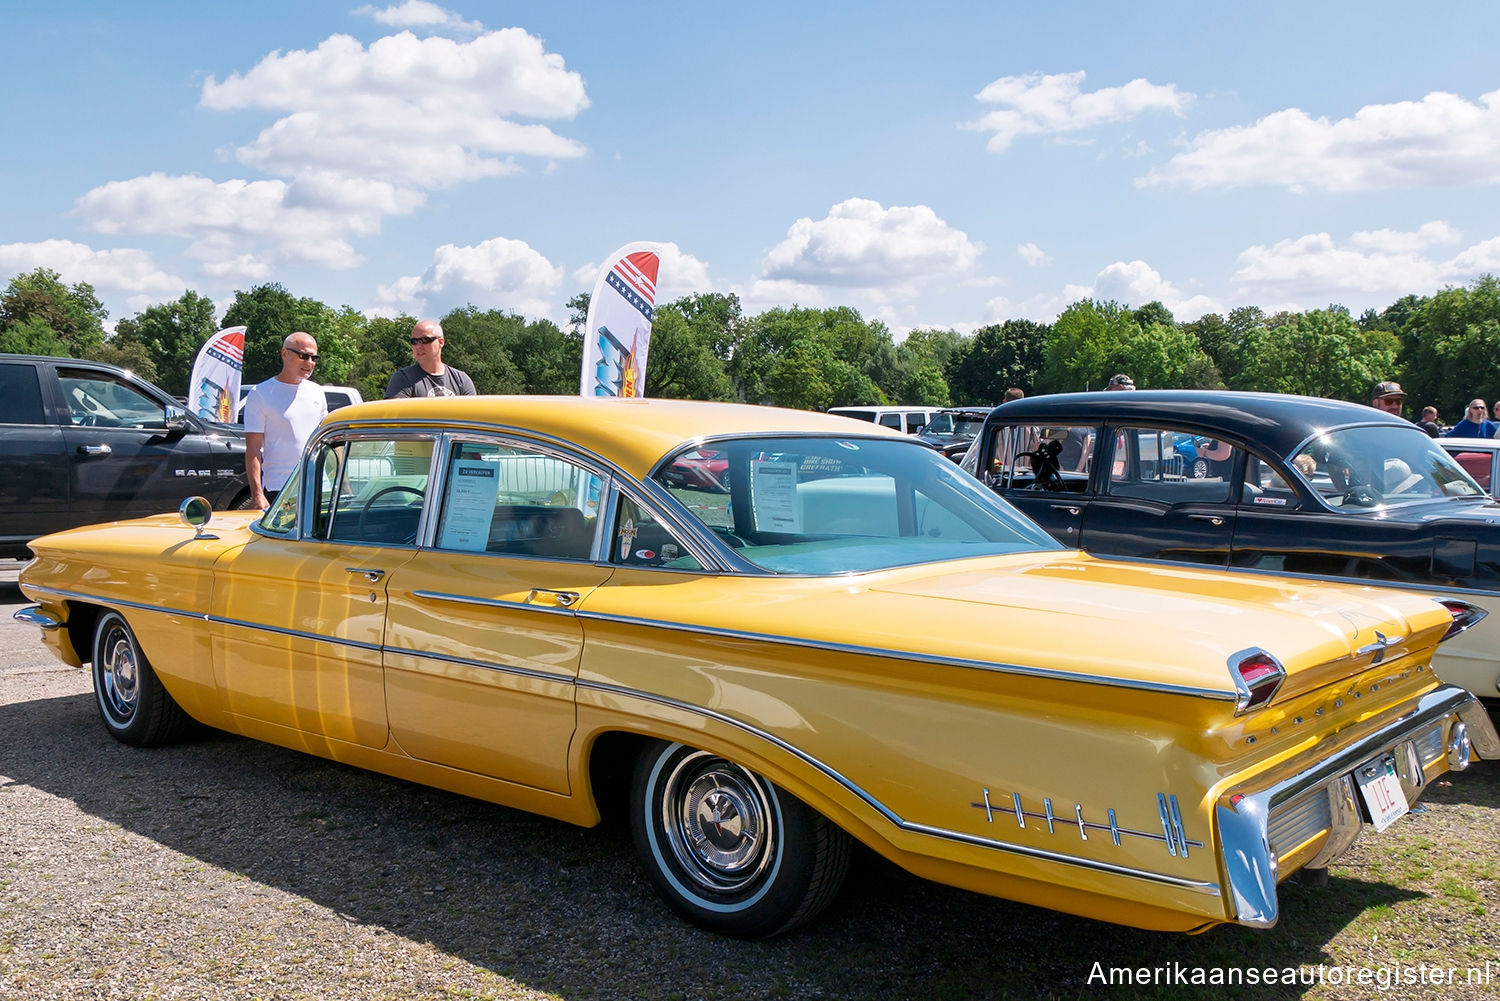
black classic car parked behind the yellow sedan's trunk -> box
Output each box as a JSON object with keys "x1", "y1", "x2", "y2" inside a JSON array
[{"x1": 963, "y1": 390, "x2": 1500, "y2": 702}]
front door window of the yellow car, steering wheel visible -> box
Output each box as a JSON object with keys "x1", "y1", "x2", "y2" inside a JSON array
[{"x1": 318, "y1": 438, "x2": 432, "y2": 546}]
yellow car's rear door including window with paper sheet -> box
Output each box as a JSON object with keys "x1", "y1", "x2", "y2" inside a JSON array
[{"x1": 384, "y1": 435, "x2": 611, "y2": 792}]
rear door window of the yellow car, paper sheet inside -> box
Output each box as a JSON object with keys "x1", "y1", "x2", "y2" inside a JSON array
[{"x1": 438, "y1": 441, "x2": 603, "y2": 560}]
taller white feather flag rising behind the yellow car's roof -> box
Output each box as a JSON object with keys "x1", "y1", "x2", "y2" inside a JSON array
[{"x1": 579, "y1": 243, "x2": 662, "y2": 396}]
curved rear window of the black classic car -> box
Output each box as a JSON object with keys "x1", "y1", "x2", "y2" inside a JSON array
[{"x1": 1290, "y1": 426, "x2": 1485, "y2": 512}]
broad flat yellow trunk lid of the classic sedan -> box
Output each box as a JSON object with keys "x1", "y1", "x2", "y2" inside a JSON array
[{"x1": 762, "y1": 551, "x2": 1452, "y2": 708}]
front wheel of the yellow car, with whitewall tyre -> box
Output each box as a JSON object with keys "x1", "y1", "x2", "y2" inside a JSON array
[{"x1": 93, "y1": 612, "x2": 188, "y2": 747}]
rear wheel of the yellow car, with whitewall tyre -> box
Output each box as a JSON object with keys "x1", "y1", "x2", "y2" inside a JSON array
[{"x1": 630, "y1": 741, "x2": 849, "y2": 938}]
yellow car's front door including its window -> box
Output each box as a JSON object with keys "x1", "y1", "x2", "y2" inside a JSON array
[{"x1": 213, "y1": 435, "x2": 434, "y2": 747}]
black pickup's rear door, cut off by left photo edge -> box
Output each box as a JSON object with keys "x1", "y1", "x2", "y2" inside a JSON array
[{"x1": 0, "y1": 360, "x2": 71, "y2": 551}]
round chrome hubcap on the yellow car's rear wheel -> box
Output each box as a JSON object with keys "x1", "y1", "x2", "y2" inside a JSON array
[{"x1": 662, "y1": 753, "x2": 774, "y2": 893}]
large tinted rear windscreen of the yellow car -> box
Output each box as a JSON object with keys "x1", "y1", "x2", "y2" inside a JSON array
[{"x1": 654, "y1": 437, "x2": 1061, "y2": 573}]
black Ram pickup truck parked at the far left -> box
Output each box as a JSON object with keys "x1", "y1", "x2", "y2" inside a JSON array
[{"x1": 0, "y1": 354, "x2": 249, "y2": 560}]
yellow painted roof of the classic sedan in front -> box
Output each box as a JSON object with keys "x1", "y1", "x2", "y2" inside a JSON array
[{"x1": 326, "y1": 396, "x2": 900, "y2": 477}]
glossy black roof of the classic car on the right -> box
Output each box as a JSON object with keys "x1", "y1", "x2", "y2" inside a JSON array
[{"x1": 987, "y1": 389, "x2": 1425, "y2": 456}]
